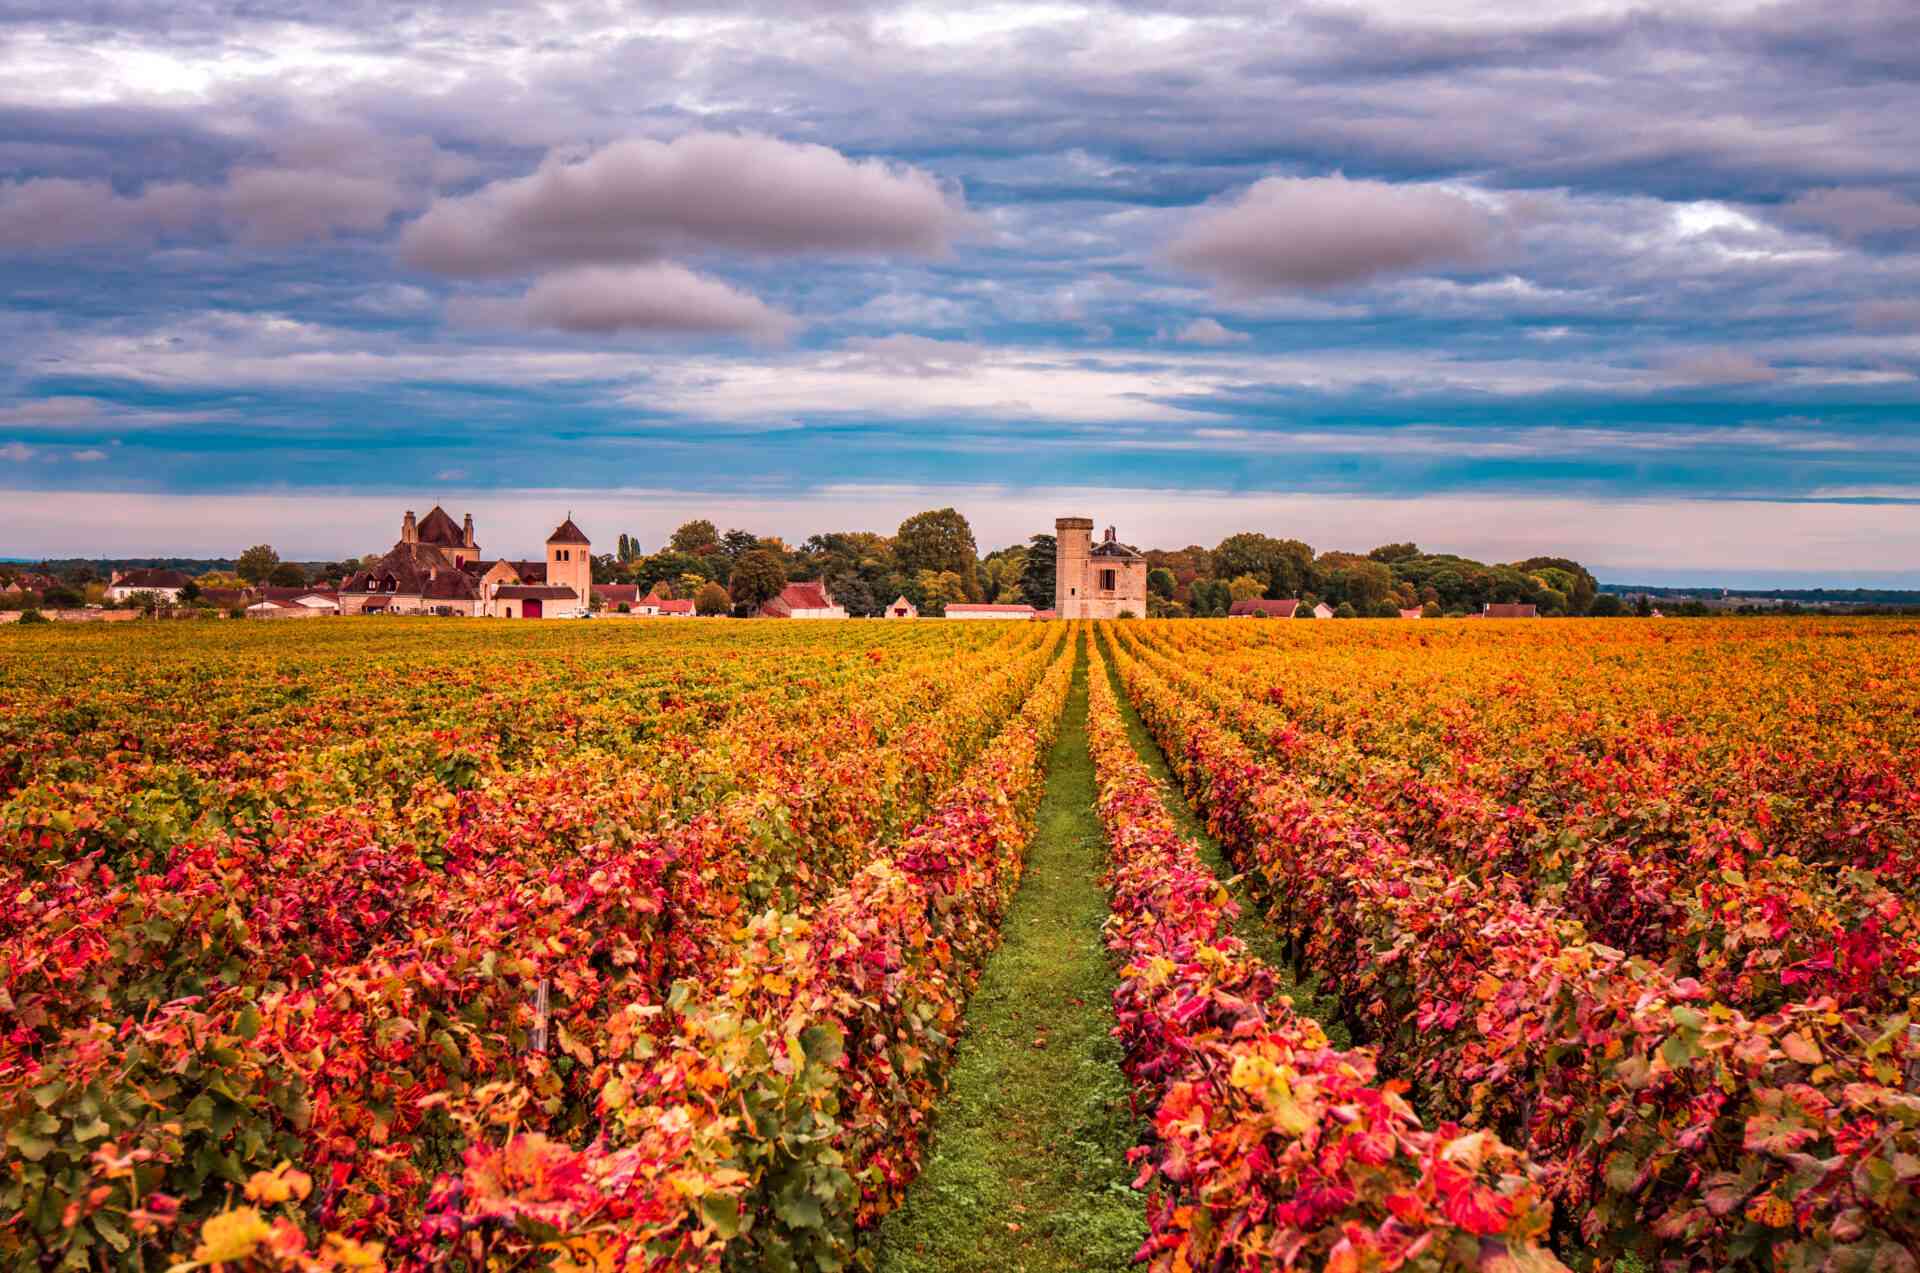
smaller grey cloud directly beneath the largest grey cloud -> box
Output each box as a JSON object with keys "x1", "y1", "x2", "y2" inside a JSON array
[{"x1": 449, "y1": 261, "x2": 799, "y2": 342}]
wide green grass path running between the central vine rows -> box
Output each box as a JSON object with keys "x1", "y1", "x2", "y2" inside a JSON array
[{"x1": 877, "y1": 633, "x2": 1146, "y2": 1273}]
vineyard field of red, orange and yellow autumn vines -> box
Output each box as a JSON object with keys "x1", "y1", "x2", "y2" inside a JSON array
[{"x1": 0, "y1": 618, "x2": 1920, "y2": 1273}]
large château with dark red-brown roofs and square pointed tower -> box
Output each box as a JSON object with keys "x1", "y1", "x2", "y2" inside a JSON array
[{"x1": 340, "y1": 505, "x2": 593, "y2": 618}]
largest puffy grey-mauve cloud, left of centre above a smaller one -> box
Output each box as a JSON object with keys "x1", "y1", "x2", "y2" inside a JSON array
[{"x1": 399, "y1": 132, "x2": 972, "y2": 276}]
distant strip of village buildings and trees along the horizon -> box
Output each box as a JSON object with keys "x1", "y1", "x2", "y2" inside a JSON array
[{"x1": 11, "y1": 505, "x2": 1889, "y2": 622}]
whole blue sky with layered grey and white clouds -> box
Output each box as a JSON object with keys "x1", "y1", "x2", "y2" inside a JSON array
[{"x1": 0, "y1": 0, "x2": 1920, "y2": 582}]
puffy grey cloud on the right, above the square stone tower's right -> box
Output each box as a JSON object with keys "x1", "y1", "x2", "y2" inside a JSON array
[{"x1": 1167, "y1": 177, "x2": 1500, "y2": 296}]
